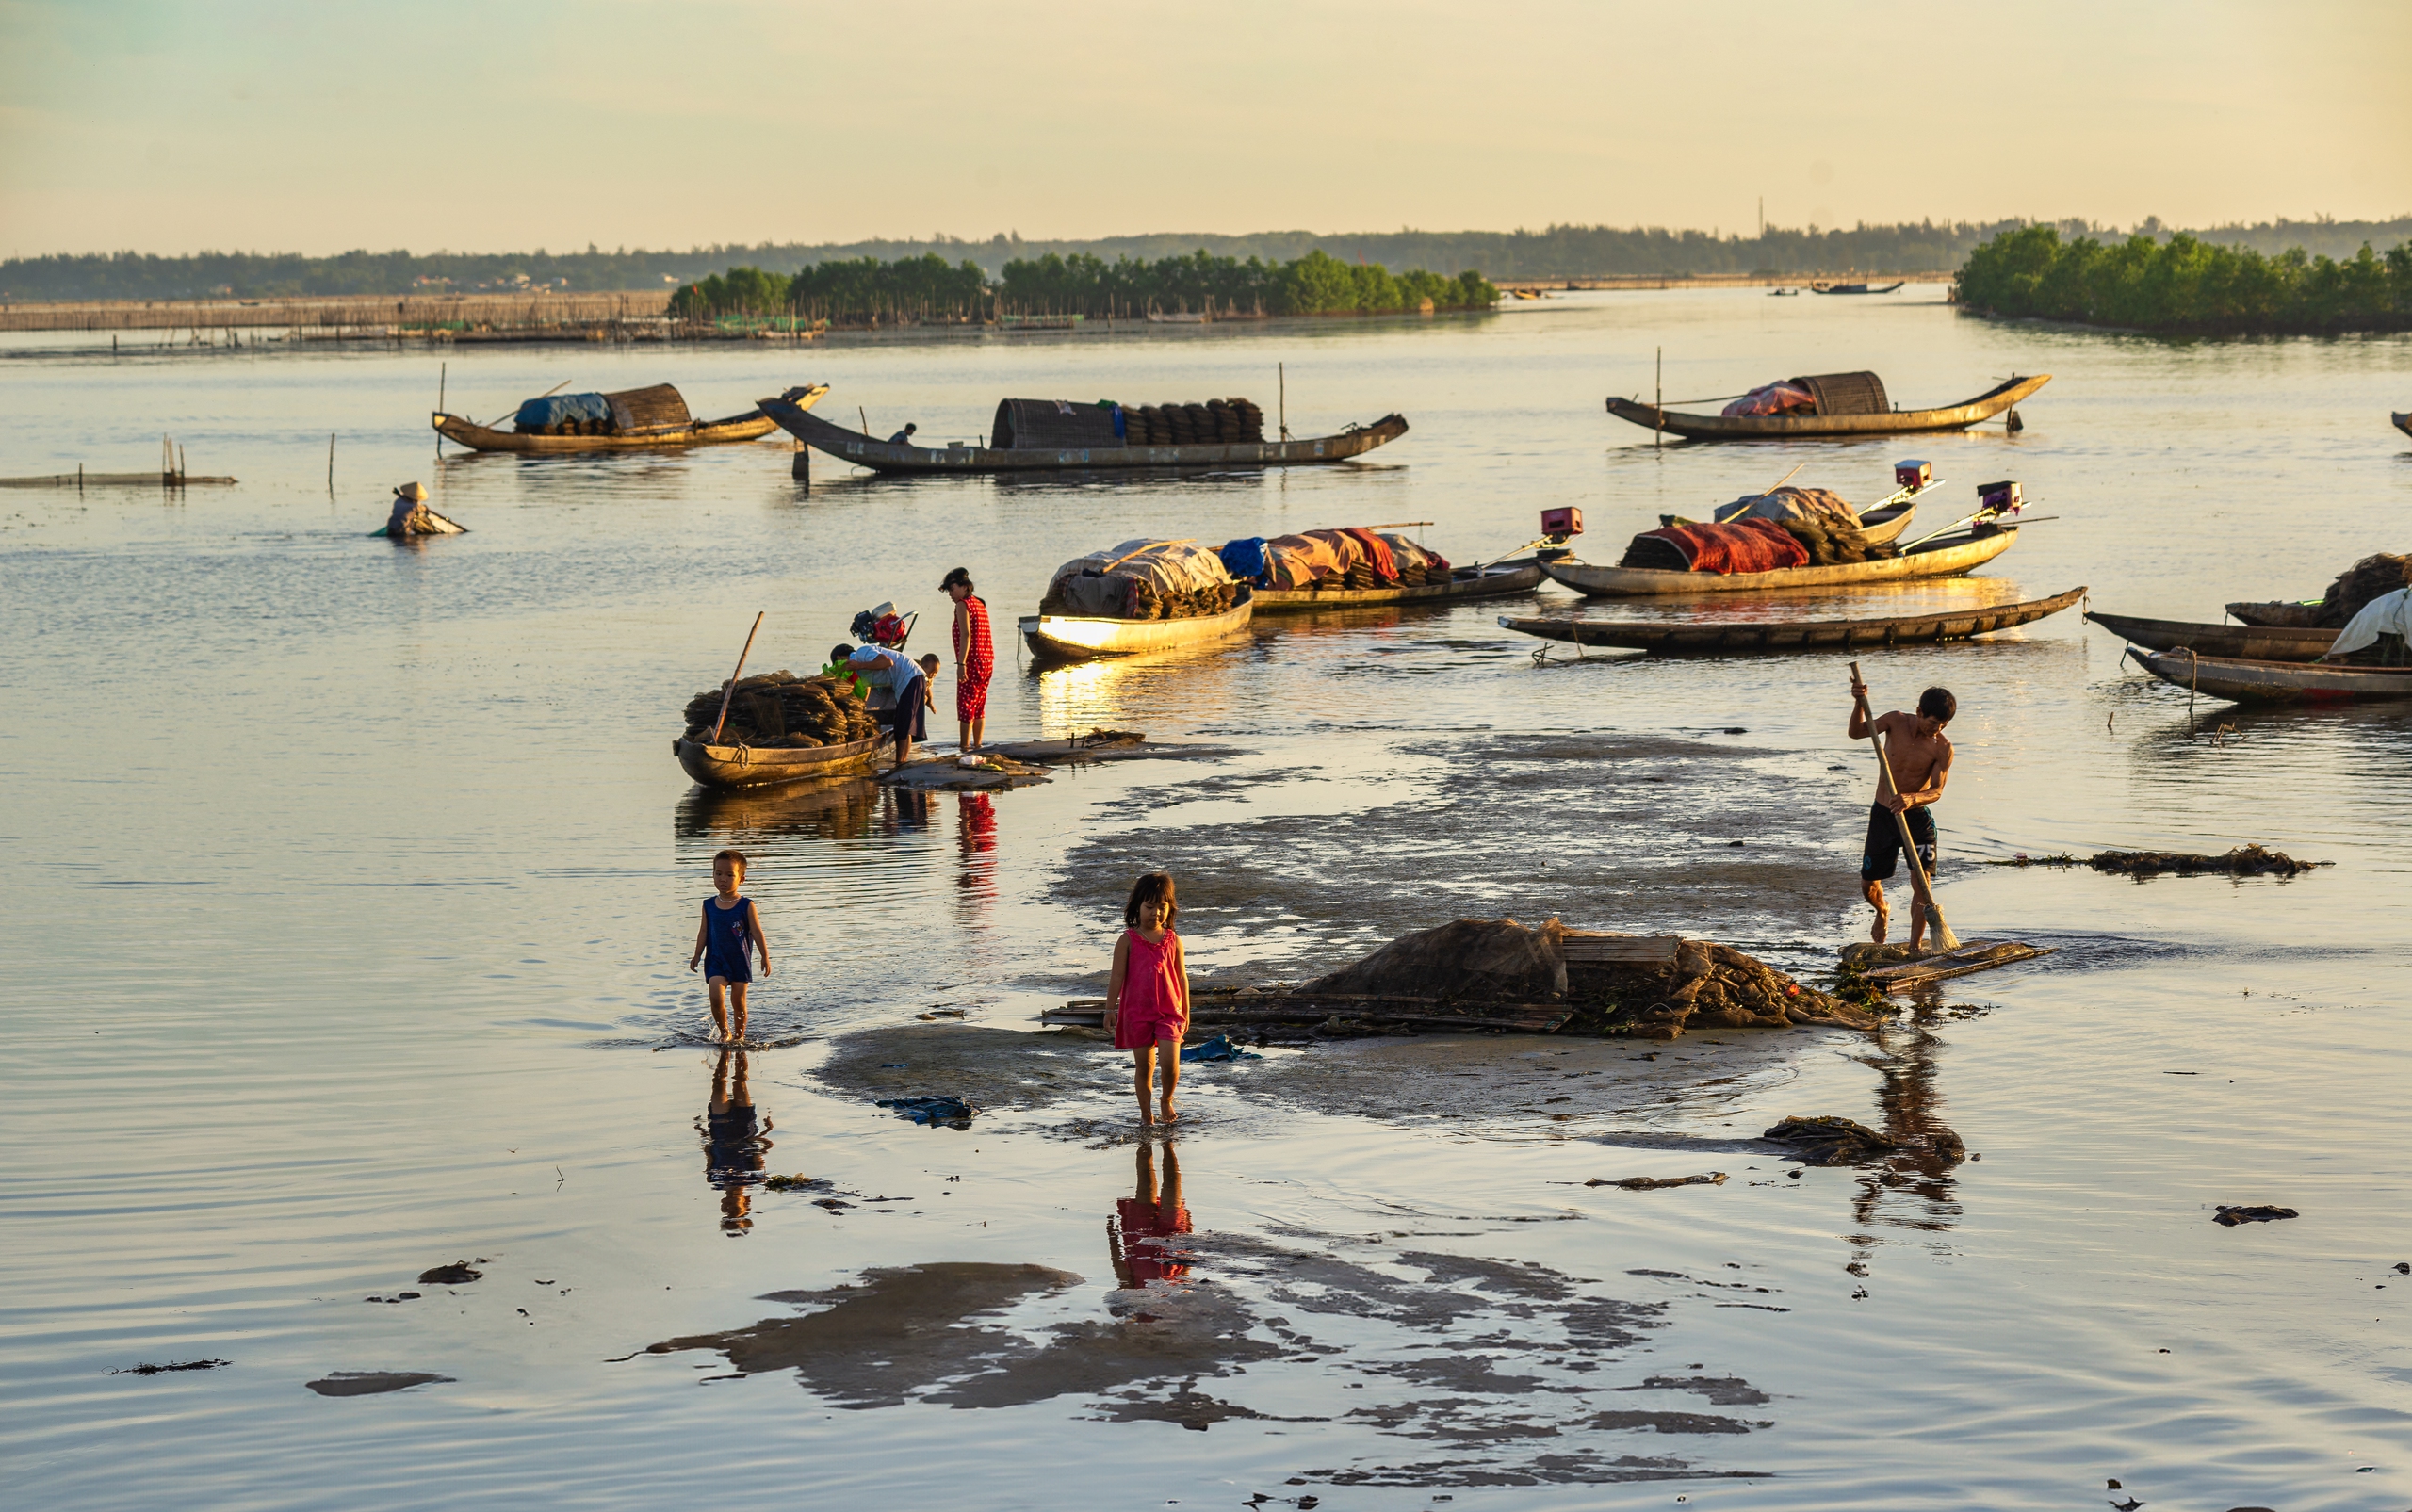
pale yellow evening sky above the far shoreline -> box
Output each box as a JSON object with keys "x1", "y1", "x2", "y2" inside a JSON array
[{"x1": 0, "y1": 0, "x2": 2412, "y2": 255}]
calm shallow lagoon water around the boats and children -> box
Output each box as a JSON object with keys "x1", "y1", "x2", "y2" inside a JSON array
[{"x1": 14, "y1": 289, "x2": 2412, "y2": 1512}]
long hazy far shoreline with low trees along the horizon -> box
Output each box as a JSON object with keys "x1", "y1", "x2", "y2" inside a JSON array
[{"x1": 14, "y1": 217, "x2": 2412, "y2": 309}]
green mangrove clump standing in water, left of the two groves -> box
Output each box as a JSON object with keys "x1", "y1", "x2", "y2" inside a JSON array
[{"x1": 671, "y1": 251, "x2": 1498, "y2": 326}]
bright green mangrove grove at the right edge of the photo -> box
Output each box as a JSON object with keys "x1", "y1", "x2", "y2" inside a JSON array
[{"x1": 1956, "y1": 227, "x2": 2412, "y2": 335}]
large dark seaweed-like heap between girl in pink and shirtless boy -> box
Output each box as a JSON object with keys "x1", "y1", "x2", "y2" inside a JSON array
[{"x1": 1225, "y1": 919, "x2": 1882, "y2": 1039}]
